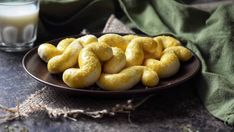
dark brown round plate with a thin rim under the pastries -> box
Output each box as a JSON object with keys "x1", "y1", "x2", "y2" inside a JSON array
[{"x1": 22, "y1": 34, "x2": 200, "y2": 97}]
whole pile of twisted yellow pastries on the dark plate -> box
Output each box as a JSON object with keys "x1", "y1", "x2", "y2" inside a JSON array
[{"x1": 38, "y1": 34, "x2": 192, "y2": 91}]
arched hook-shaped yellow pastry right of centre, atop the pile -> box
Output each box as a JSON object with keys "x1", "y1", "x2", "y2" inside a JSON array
[{"x1": 125, "y1": 37, "x2": 162, "y2": 67}]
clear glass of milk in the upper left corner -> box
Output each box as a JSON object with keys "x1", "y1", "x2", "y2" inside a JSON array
[{"x1": 0, "y1": 0, "x2": 39, "y2": 52}]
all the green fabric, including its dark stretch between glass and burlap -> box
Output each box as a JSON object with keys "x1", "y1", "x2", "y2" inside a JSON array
[{"x1": 38, "y1": 0, "x2": 234, "y2": 125}]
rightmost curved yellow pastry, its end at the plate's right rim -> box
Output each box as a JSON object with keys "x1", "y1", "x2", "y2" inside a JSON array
[{"x1": 163, "y1": 46, "x2": 192, "y2": 61}]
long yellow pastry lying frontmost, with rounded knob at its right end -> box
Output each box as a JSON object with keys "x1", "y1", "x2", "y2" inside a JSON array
[{"x1": 97, "y1": 66, "x2": 159, "y2": 91}]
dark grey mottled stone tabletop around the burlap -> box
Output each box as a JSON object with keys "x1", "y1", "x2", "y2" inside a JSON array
[{"x1": 0, "y1": 51, "x2": 234, "y2": 132}]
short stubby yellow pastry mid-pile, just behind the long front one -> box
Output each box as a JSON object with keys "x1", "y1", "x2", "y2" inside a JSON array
[{"x1": 103, "y1": 47, "x2": 126, "y2": 74}]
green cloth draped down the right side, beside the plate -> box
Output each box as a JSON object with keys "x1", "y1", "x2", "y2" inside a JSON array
[{"x1": 119, "y1": 0, "x2": 234, "y2": 125}]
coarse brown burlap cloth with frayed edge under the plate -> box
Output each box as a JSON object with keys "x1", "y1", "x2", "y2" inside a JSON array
[{"x1": 0, "y1": 15, "x2": 152, "y2": 122}]
